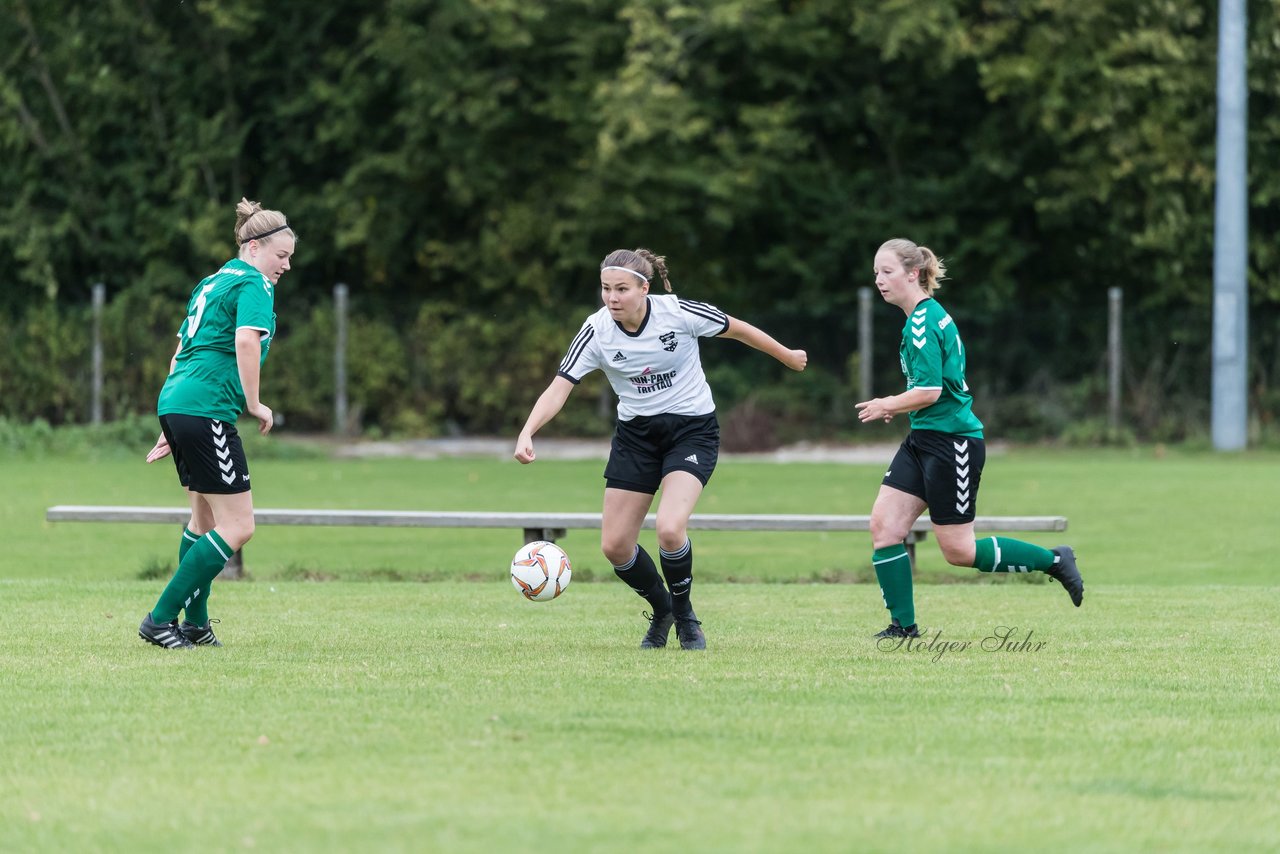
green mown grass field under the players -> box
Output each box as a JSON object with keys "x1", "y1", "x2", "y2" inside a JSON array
[{"x1": 0, "y1": 449, "x2": 1280, "y2": 851}]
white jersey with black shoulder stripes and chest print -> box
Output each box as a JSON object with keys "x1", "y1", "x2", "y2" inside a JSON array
[{"x1": 558, "y1": 294, "x2": 728, "y2": 421}]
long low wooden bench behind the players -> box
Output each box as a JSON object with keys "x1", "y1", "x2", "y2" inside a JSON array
[{"x1": 45, "y1": 504, "x2": 1066, "y2": 579}]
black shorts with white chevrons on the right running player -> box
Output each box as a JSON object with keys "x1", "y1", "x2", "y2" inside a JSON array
[{"x1": 882, "y1": 430, "x2": 987, "y2": 525}]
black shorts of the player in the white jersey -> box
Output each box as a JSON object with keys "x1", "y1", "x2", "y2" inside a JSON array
[{"x1": 604, "y1": 412, "x2": 719, "y2": 495}]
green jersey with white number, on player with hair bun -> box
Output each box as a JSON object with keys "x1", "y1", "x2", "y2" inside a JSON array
[{"x1": 156, "y1": 259, "x2": 275, "y2": 421}]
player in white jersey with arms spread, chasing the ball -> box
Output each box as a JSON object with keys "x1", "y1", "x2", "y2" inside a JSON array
[{"x1": 515, "y1": 248, "x2": 809, "y2": 649}]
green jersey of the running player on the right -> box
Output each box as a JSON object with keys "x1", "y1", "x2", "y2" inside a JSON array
[{"x1": 897, "y1": 297, "x2": 982, "y2": 438}]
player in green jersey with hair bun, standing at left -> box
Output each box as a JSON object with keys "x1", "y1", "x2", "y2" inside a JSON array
[{"x1": 138, "y1": 198, "x2": 297, "y2": 649}]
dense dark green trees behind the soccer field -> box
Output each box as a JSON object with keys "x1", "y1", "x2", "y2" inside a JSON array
[{"x1": 0, "y1": 0, "x2": 1280, "y2": 438}]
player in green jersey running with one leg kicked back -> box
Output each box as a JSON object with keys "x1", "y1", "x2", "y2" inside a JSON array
[{"x1": 856, "y1": 239, "x2": 1084, "y2": 638}]
